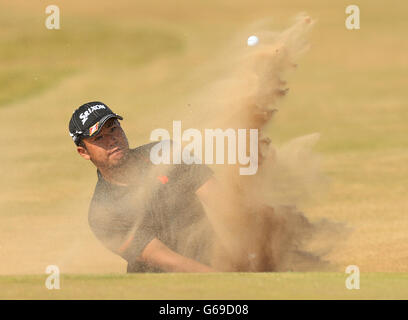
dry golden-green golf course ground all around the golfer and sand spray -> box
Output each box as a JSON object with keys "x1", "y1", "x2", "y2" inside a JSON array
[{"x1": 0, "y1": 0, "x2": 408, "y2": 299}]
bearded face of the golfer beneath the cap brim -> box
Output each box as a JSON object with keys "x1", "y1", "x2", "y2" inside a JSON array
[{"x1": 77, "y1": 118, "x2": 129, "y2": 168}]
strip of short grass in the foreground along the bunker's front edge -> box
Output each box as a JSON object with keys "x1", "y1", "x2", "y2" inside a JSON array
[{"x1": 0, "y1": 273, "x2": 408, "y2": 300}]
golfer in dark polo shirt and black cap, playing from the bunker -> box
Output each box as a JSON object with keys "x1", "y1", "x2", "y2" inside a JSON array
[{"x1": 69, "y1": 101, "x2": 214, "y2": 272}]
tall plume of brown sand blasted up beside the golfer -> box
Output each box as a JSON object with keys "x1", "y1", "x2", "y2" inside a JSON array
[{"x1": 177, "y1": 15, "x2": 346, "y2": 271}]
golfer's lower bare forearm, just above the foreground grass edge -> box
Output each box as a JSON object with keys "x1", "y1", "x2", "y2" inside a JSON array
[{"x1": 140, "y1": 238, "x2": 215, "y2": 272}]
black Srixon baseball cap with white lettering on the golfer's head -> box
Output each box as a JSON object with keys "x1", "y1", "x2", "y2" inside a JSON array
[{"x1": 69, "y1": 101, "x2": 123, "y2": 146}]
